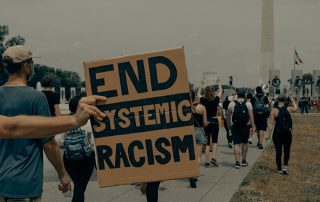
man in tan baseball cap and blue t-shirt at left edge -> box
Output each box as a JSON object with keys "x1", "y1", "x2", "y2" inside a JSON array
[{"x1": 0, "y1": 45, "x2": 71, "y2": 202}]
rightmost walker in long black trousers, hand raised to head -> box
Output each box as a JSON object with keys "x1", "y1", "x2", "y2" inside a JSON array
[{"x1": 266, "y1": 95, "x2": 298, "y2": 175}]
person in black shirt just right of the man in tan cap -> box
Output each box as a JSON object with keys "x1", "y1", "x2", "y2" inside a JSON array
[{"x1": 41, "y1": 76, "x2": 61, "y2": 116}]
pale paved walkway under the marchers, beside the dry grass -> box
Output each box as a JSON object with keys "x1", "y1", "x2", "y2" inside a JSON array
[{"x1": 42, "y1": 128, "x2": 263, "y2": 202}]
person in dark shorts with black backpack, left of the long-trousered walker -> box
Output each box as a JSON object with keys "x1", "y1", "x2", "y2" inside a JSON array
[{"x1": 227, "y1": 92, "x2": 254, "y2": 169}]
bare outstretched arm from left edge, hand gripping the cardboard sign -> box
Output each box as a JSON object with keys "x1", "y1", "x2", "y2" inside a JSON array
[{"x1": 0, "y1": 96, "x2": 106, "y2": 138}]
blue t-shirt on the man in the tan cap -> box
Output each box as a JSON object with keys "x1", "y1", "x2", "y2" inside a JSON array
[{"x1": 0, "y1": 86, "x2": 52, "y2": 198}]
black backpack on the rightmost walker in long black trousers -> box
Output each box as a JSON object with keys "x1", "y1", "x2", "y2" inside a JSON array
[{"x1": 275, "y1": 107, "x2": 292, "y2": 134}]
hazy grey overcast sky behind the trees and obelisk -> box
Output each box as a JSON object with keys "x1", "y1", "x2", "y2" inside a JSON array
[{"x1": 0, "y1": 0, "x2": 320, "y2": 87}]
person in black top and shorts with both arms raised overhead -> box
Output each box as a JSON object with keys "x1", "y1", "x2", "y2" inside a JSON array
[{"x1": 199, "y1": 79, "x2": 222, "y2": 168}]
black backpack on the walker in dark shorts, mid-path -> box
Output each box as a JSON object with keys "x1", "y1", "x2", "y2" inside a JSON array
[{"x1": 232, "y1": 100, "x2": 249, "y2": 127}]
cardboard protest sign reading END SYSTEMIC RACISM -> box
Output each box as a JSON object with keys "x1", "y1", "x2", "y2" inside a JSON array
[{"x1": 84, "y1": 48, "x2": 200, "y2": 186}]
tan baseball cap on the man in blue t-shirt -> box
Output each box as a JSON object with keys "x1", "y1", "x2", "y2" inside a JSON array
[{"x1": 2, "y1": 45, "x2": 34, "y2": 63}]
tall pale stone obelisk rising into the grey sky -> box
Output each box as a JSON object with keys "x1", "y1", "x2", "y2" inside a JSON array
[{"x1": 259, "y1": 0, "x2": 274, "y2": 84}]
